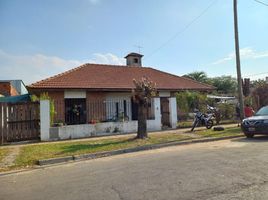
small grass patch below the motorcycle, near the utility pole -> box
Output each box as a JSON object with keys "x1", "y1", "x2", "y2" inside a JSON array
[{"x1": 195, "y1": 127, "x2": 242, "y2": 137}]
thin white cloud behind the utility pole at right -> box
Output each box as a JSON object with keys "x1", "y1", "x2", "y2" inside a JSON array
[{"x1": 212, "y1": 47, "x2": 268, "y2": 65}]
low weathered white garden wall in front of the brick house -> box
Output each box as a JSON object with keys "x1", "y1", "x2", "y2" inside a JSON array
[{"x1": 49, "y1": 120, "x2": 161, "y2": 140}]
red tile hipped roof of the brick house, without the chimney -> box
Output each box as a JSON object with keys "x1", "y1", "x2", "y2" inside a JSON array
[{"x1": 28, "y1": 64, "x2": 214, "y2": 91}]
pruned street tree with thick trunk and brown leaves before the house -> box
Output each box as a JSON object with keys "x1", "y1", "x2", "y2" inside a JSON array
[{"x1": 132, "y1": 77, "x2": 156, "y2": 139}]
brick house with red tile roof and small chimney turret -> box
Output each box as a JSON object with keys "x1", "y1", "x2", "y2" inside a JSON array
[{"x1": 28, "y1": 53, "x2": 214, "y2": 128}]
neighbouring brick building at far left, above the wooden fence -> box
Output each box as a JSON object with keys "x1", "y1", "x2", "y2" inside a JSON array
[{"x1": 0, "y1": 80, "x2": 28, "y2": 97}]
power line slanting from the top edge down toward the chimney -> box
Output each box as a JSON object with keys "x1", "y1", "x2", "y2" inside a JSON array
[{"x1": 144, "y1": 0, "x2": 217, "y2": 60}]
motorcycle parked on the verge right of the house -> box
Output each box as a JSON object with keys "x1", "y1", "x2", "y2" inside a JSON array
[{"x1": 191, "y1": 110, "x2": 213, "y2": 131}]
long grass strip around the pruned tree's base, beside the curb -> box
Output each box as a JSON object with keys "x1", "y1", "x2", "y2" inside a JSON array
[{"x1": 15, "y1": 133, "x2": 190, "y2": 167}]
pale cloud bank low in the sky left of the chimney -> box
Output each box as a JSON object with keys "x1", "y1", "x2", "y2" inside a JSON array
[{"x1": 0, "y1": 49, "x2": 125, "y2": 84}]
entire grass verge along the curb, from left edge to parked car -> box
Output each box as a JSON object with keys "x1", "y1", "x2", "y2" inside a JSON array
[{"x1": 0, "y1": 127, "x2": 242, "y2": 171}]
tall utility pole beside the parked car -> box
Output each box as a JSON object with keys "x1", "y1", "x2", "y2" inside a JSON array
[{"x1": 234, "y1": 0, "x2": 245, "y2": 120}]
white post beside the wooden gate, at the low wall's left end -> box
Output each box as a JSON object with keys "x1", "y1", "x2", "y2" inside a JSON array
[{"x1": 40, "y1": 100, "x2": 50, "y2": 141}]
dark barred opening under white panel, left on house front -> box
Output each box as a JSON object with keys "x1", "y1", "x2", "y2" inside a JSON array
[{"x1": 65, "y1": 98, "x2": 87, "y2": 125}]
